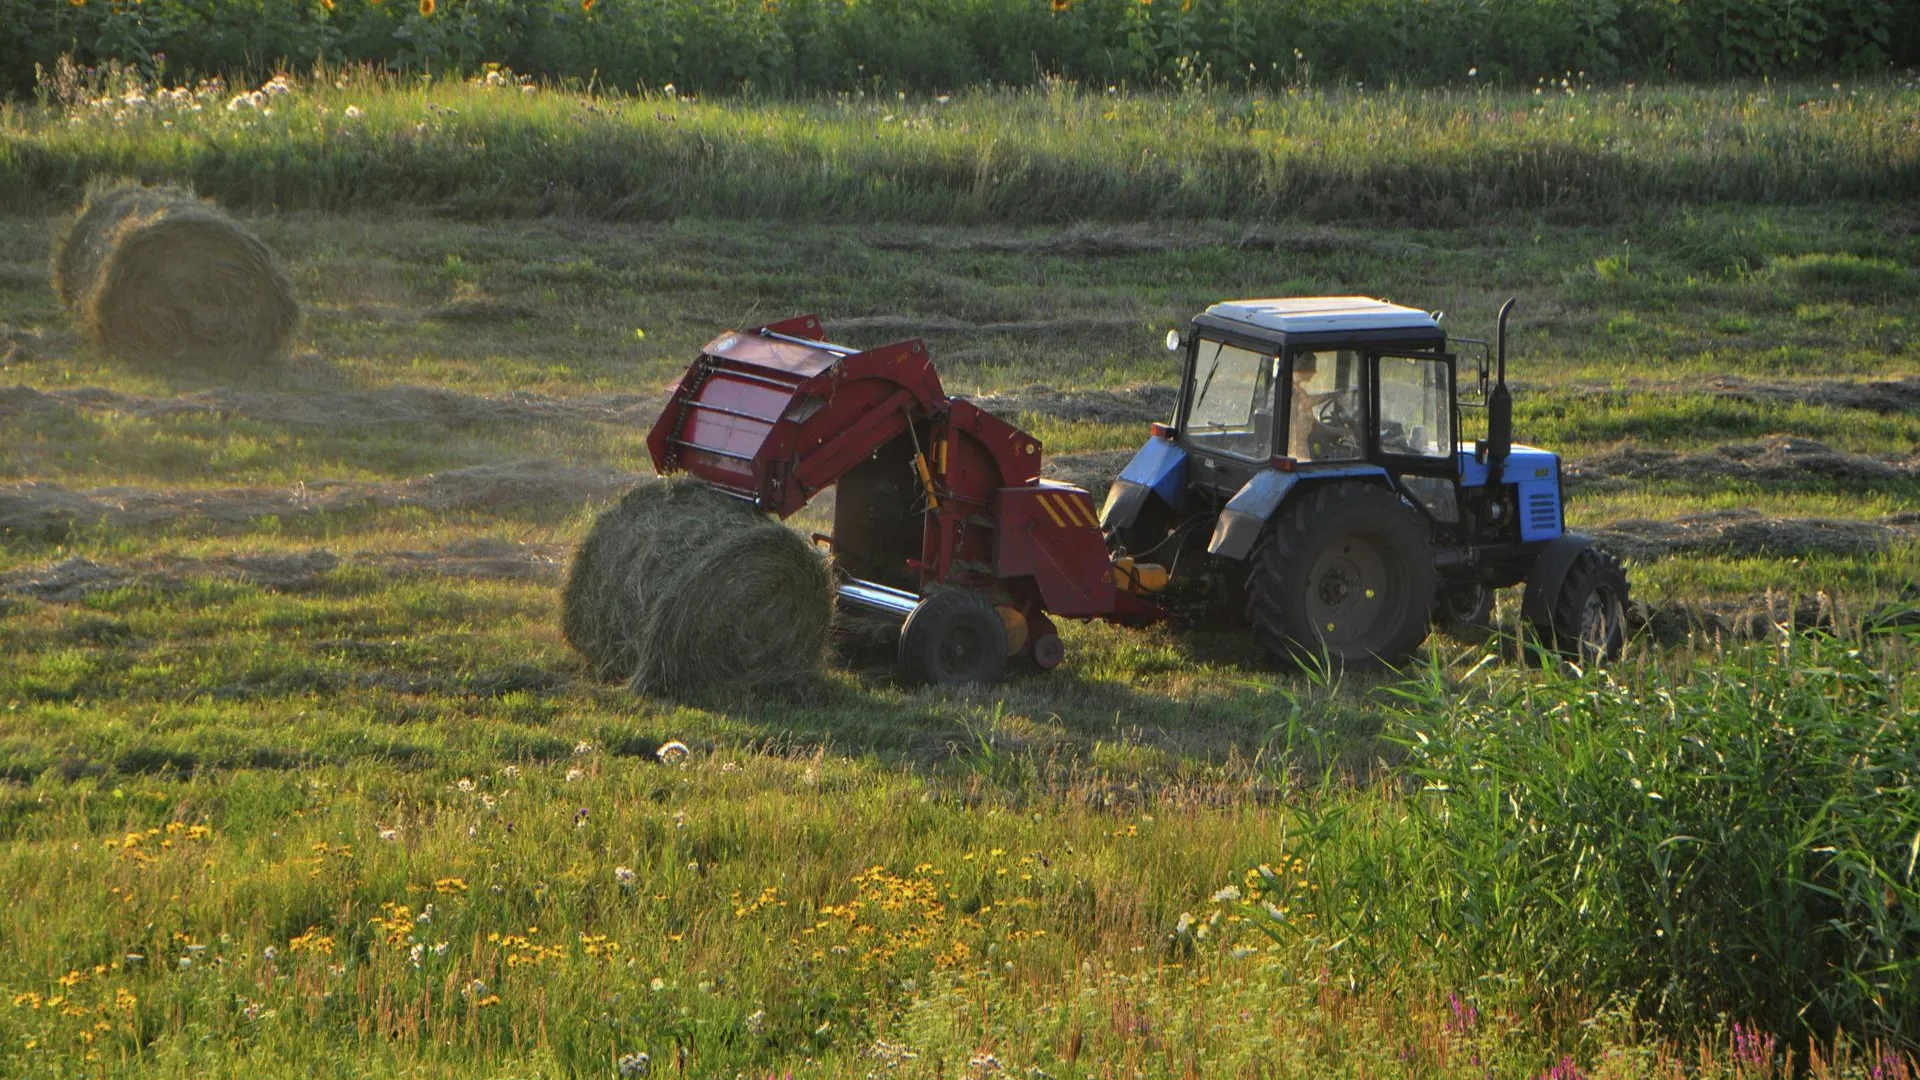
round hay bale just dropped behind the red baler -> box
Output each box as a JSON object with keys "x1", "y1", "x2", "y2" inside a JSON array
[{"x1": 561, "y1": 480, "x2": 833, "y2": 696}]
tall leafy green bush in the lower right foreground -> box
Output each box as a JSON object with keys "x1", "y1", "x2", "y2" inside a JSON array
[{"x1": 1233, "y1": 638, "x2": 1920, "y2": 1043}]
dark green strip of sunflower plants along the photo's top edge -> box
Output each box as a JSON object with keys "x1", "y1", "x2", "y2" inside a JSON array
[{"x1": 0, "y1": 0, "x2": 1920, "y2": 96}]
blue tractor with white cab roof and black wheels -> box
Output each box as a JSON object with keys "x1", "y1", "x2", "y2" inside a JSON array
[{"x1": 1100, "y1": 296, "x2": 1628, "y2": 667}]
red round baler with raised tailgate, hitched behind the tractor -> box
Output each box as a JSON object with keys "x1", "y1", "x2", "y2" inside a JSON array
[{"x1": 647, "y1": 315, "x2": 1167, "y2": 682}]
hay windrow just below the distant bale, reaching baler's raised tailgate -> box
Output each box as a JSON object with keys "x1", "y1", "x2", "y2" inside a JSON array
[{"x1": 0, "y1": 386, "x2": 660, "y2": 429}]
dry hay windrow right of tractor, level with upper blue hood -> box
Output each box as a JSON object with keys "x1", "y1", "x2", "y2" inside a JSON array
[{"x1": 1567, "y1": 436, "x2": 1920, "y2": 486}]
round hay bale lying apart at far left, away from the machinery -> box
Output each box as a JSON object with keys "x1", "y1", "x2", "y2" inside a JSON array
[{"x1": 52, "y1": 184, "x2": 300, "y2": 365}]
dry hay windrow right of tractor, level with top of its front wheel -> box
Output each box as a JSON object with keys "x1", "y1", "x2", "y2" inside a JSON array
[{"x1": 1588, "y1": 509, "x2": 1920, "y2": 561}]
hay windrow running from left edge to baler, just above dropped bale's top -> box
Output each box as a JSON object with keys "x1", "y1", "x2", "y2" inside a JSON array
[{"x1": 0, "y1": 461, "x2": 641, "y2": 540}]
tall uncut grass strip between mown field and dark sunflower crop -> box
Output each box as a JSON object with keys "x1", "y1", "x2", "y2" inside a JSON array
[{"x1": 11, "y1": 77, "x2": 1920, "y2": 225}]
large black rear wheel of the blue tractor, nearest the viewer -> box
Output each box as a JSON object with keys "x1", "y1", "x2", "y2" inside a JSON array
[{"x1": 1246, "y1": 482, "x2": 1434, "y2": 669}]
